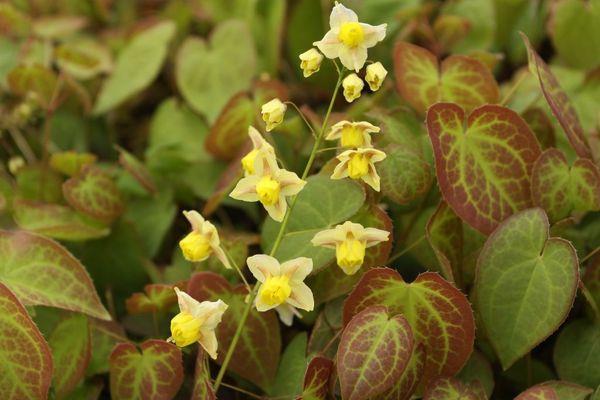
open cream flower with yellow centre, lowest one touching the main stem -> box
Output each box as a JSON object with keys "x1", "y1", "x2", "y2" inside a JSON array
[{"x1": 247, "y1": 254, "x2": 315, "y2": 326}]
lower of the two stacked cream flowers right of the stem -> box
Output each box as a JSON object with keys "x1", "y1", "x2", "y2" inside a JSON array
[{"x1": 331, "y1": 148, "x2": 386, "y2": 192}]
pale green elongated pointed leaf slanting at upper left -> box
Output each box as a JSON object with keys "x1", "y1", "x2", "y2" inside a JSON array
[{"x1": 93, "y1": 21, "x2": 175, "y2": 115}]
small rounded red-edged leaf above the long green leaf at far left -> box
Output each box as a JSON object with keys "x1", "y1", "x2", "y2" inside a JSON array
[{"x1": 63, "y1": 165, "x2": 123, "y2": 222}]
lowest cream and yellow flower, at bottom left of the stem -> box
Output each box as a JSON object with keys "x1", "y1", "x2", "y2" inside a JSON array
[{"x1": 167, "y1": 288, "x2": 228, "y2": 359}]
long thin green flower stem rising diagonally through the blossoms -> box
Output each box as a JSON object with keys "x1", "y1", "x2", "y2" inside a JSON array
[{"x1": 214, "y1": 70, "x2": 343, "y2": 393}]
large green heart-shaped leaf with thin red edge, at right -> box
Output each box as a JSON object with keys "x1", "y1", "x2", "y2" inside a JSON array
[{"x1": 475, "y1": 208, "x2": 579, "y2": 370}]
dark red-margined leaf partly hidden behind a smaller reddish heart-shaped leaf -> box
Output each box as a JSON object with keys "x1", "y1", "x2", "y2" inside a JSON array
[{"x1": 344, "y1": 268, "x2": 475, "y2": 385}]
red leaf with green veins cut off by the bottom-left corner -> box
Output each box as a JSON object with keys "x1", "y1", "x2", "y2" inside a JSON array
[{"x1": 0, "y1": 283, "x2": 52, "y2": 400}]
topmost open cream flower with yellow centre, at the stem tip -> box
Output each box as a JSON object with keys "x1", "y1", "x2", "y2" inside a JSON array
[{"x1": 313, "y1": 2, "x2": 387, "y2": 72}]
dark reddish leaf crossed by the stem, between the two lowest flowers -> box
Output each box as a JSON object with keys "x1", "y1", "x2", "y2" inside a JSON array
[{"x1": 187, "y1": 272, "x2": 281, "y2": 389}]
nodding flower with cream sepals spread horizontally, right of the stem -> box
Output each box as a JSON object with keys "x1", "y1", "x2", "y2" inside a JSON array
[{"x1": 311, "y1": 221, "x2": 390, "y2": 275}]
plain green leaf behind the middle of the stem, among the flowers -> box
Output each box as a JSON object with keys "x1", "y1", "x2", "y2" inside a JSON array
[{"x1": 261, "y1": 175, "x2": 365, "y2": 274}]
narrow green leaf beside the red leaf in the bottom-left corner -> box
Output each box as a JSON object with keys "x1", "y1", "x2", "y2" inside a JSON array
[{"x1": 48, "y1": 314, "x2": 91, "y2": 398}]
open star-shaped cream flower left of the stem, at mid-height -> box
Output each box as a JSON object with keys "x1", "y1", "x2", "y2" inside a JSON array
[{"x1": 229, "y1": 157, "x2": 306, "y2": 221}]
